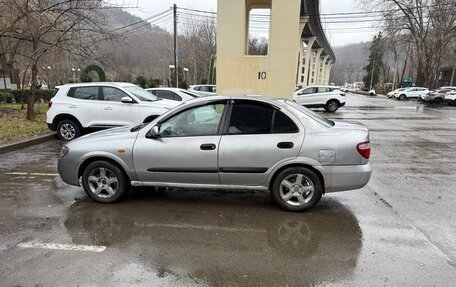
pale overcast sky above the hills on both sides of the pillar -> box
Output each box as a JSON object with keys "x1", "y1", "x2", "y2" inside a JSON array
[{"x1": 116, "y1": 0, "x2": 375, "y2": 46}]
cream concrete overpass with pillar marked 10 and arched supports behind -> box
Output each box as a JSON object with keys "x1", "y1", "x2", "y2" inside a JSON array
[{"x1": 216, "y1": 0, "x2": 336, "y2": 98}]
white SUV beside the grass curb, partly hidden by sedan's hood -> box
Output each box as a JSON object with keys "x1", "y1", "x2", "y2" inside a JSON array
[{"x1": 46, "y1": 83, "x2": 180, "y2": 140}]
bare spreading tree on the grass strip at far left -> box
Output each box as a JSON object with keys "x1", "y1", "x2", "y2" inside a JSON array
[{"x1": 0, "y1": 0, "x2": 114, "y2": 120}]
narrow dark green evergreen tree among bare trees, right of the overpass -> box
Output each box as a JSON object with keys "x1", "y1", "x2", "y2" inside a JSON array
[{"x1": 363, "y1": 32, "x2": 384, "y2": 89}]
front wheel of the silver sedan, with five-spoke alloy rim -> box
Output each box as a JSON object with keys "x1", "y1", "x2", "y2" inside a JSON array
[{"x1": 82, "y1": 160, "x2": 130, "y2": 203}]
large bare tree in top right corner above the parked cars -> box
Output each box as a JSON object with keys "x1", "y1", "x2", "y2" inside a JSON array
[{"x1": 360, "y1": 0, "x2": 456, "y2": 87}]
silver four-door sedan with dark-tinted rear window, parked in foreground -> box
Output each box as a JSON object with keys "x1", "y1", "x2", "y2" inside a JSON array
[{"x1": 58, "y1": 96, "x2": 371, "y2": 211}]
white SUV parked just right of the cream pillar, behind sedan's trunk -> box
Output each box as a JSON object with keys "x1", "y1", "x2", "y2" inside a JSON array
[{"x1": 293, "y1": 86, "x2": 345, "y2": 113}]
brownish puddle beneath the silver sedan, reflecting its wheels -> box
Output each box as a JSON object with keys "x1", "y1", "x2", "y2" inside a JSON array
[{"x1": 64, "y1": 192, "x2": 362, "y2": 286}]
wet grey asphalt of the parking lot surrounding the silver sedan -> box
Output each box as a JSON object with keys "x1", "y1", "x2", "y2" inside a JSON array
[{"x1": 0, "y1": 94, "x2": 456, "y2": 286}]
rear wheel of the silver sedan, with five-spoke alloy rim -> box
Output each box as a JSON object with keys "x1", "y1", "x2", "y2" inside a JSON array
[{"x1": 271, "y1": 167, "x2": 323, "y2": 212}]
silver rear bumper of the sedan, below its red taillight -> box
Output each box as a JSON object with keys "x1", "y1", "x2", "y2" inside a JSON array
[{"x1": 321, "y1": 163, "x2": 372, "y2": 192}]
